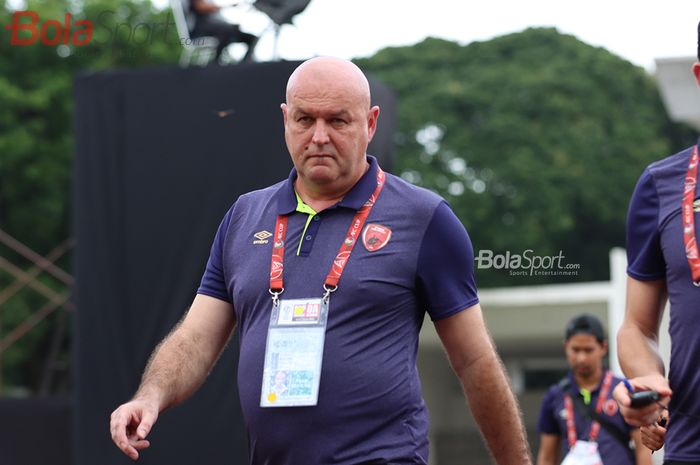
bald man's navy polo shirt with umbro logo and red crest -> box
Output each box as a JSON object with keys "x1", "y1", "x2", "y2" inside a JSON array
[{"x1": 198, "y1": 157, "x2": 478, "y2": 465}]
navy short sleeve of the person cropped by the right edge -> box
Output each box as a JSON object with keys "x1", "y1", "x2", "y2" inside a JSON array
[{"x1": 627, "y1": 169, "x2": 666, "y2": 281}]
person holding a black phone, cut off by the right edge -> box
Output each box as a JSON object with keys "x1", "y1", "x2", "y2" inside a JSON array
[{"x1": 614, "y1": 20, "x2": 700, "y2": 465}]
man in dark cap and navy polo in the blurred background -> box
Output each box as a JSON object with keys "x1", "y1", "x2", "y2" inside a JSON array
[{"x1": 537, "y1": 314, "x2": 651, "y2": 465}]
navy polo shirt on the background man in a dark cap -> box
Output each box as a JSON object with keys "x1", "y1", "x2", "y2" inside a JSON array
[{"x1": 537, "y1": 372, "x2": 635, "y2": 465}]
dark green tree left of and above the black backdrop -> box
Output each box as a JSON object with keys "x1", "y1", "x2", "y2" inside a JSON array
[{"x1": 0, "y1": 0, "x2": 181, "y2": 392}]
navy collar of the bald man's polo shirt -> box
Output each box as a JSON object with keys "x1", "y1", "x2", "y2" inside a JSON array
[{"x1": 277, "y1": 155, "x2": 379, "y2": 215}]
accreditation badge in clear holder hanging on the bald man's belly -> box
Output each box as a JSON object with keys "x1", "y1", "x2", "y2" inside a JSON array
[{"x1": 260, "y1": 298, "x2": 328, "y2": 407}]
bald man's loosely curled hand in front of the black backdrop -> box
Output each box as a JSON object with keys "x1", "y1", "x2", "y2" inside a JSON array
[{"x1": 110, "y1": 399, "x2": 159, "y2": 460}]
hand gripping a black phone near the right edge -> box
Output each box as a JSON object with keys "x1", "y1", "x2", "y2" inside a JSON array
[{"x1": 613, "y1": 374, "x2": 672, "y2": 426}]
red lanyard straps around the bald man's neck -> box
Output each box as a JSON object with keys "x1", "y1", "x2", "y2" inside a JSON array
[{"x1": 270, "y1": 167, "x2": 386, "y2": 304}]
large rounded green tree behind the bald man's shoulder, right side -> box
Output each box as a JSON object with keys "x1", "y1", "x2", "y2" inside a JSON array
[{"x1": 357, "y1": 29, "x2": 694, "y2": 286}]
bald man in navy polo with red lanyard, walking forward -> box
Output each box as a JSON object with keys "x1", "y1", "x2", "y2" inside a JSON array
[{"x1": 111, "y1": 57, "x2": 531, "y2": 465}]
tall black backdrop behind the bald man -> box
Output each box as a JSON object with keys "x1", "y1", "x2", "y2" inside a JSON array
[{"x1": 73, "y1": 62, "x2": 395, "y2": 465}]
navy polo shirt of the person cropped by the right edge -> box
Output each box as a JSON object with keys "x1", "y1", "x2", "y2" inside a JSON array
[{"x1": 627, "y1": 139, "x2": 700, "y2": 461}]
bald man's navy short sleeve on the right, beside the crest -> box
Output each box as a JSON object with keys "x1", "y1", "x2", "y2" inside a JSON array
[{"x1": 416, "y1": 202, "x2": 479, "y2": 321}]
